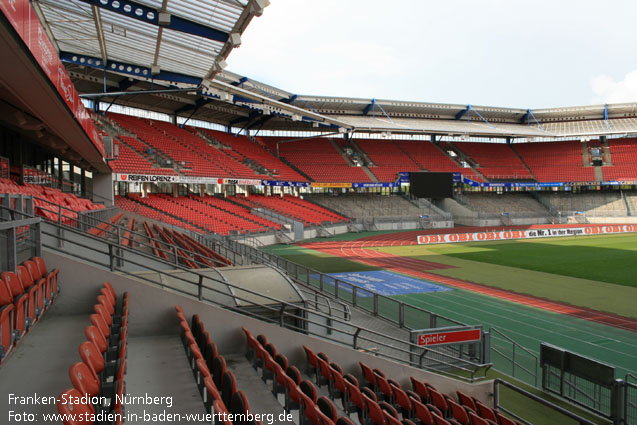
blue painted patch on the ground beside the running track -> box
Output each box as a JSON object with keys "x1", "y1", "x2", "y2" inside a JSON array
[{"x1": 326, "y1": 270, "x2": 452, "y2": 296}]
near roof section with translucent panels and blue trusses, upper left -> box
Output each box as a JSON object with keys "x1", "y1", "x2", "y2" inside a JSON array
[{"x1": 33, "y1": 0, "x2": 267, "y2": 78}]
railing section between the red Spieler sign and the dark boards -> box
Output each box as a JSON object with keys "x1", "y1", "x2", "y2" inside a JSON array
[{"x1": 489, "y1": 328, "x2": 539, "y2": 387}]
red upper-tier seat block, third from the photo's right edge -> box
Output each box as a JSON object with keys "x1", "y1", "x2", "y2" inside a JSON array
[{"x1": 453, "y1": 142, "x2": 533, "y2": 180}]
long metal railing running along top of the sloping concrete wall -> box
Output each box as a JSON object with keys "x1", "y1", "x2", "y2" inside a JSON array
[{"x1": 33, "y1": 215, "x2": 489, "y2": 382}]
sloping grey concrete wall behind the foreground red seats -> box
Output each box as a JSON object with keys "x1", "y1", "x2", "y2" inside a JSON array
[{"x1": 43, "y1": 250, "x2": 493, "y2": 404}]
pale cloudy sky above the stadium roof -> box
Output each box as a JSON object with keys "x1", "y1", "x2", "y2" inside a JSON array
[{"x1": 227, "y1": 0, "x2": 637, "y2": 108}]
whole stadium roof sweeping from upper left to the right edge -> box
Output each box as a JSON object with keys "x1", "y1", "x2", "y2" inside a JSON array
[{"x1": 34, "y1": 0, "x2": 637, "y2": 139}]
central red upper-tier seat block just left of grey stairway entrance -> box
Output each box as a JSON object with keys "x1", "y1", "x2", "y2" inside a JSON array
[{"x1": 262, "y1": 137, "x2": 371, "y2": 183}]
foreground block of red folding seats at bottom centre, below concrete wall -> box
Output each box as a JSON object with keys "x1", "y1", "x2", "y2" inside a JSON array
[{"x1": 238, "y1": 327, "x2": 516, "y2": 425}]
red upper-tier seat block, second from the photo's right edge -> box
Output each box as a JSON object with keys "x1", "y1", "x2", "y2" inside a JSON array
[{"x1": 512, "y1": 141, "x2": 595, "y2": 182}]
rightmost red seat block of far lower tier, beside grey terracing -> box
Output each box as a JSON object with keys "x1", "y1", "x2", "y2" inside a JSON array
[{"x1": 232, "y1": 195, "x2": 347, "y2": 225}]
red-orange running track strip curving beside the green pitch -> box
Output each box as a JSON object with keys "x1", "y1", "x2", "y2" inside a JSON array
[{"x1": 299, "y1": 228, "x2": 637, "y2": 332}]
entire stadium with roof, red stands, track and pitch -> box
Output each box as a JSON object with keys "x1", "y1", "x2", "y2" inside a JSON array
[{"x1": 0, "y1": 0, "x2": 637, "y2": 425}]
